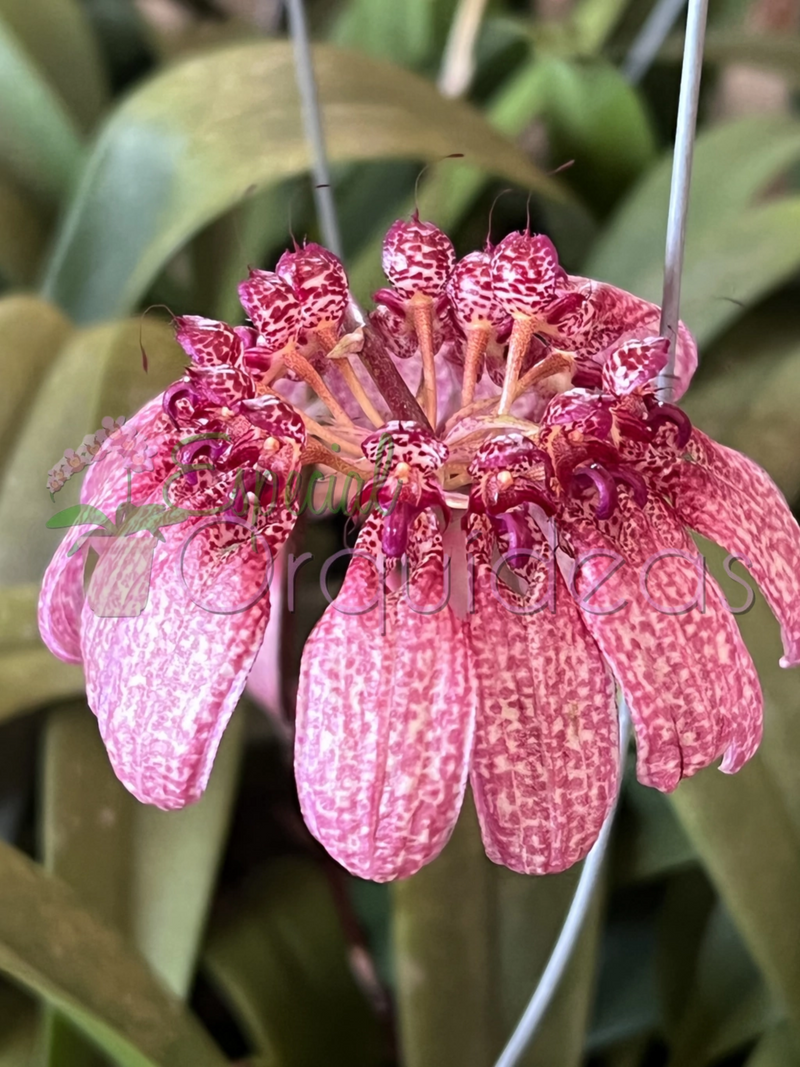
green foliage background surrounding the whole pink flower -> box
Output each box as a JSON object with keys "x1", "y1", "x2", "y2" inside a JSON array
[{"x1": 0, "y1": 0, "x2": 800, "y2": 1067}]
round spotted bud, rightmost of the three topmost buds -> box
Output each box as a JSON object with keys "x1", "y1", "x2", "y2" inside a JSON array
[{"x1": 492, "y1": 233, "x2": 566, "y2": 317}]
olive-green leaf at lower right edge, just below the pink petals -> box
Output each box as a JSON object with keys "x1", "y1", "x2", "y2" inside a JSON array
[{"x1": 671, "y1": 753, "x2": 800, "y2": 1023}]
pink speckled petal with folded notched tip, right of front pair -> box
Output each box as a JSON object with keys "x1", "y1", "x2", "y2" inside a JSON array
[{"x1": 566, "y1": 490, "x2": 762, "y2": 792}]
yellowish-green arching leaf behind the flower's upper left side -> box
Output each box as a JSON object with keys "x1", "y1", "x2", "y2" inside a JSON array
[{"x1": 0, "y1": 319, "x2": 183, "y2": 584}]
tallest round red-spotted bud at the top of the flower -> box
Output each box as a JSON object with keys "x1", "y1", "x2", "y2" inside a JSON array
[{"x1": 382, "y1": 217, "x2": 455, "y2": 298}]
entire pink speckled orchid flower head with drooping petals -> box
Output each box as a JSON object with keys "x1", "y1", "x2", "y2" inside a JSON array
[{"x1": 41, "y1": 214, "x2": 800, "y2": 880}]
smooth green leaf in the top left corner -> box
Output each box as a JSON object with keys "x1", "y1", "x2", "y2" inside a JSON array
[{"x1": 0, "y1": 18, "x2": 82, "y2": 202}]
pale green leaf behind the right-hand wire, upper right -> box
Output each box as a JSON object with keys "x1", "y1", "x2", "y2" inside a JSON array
[{"x1": 585, "y1": 116, "x2": 800, "y2": 343}]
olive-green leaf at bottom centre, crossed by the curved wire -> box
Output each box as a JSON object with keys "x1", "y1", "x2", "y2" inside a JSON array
[{"x1": 394, "y1": 798, "x2": 602, "y2": 1067}]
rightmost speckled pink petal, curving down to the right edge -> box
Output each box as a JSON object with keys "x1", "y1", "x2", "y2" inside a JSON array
[{"x1": 667, "y1": 430, "x2": 800, "y2": 667}]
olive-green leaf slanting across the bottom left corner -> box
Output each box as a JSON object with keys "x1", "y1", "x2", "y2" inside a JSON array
[{"x1": 0, "y1": 844, "x2": 226, "y2": 1067}]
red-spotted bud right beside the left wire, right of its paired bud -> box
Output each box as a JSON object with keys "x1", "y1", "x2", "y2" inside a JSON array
[{"x1": 275, "y1": 242, "x2": 350, "y2": 330}]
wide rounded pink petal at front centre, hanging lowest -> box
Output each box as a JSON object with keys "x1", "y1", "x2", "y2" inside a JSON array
[{"x1": 294, "y1": 515, "x2": 475, "y2": 881}]
